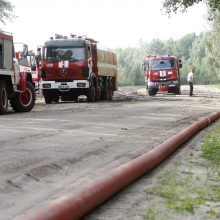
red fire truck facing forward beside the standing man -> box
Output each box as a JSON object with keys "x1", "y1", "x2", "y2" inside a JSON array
[{"x1": 143, "y1": 55, "x2": 182, "y2": 96}]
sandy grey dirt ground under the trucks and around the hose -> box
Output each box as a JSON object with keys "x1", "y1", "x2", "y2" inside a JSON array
[{"x1": 0, "y1": 85, "x2": 220, "y2": 220}]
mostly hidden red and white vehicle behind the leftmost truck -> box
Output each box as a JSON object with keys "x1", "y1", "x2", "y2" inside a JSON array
[{"x1": 16, "y1": 50, "x2": 41, "y2": 94}]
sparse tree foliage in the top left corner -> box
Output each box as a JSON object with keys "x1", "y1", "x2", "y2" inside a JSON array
[{"x1": 0, "y1": 0, "x2": 14, "y2": 24}]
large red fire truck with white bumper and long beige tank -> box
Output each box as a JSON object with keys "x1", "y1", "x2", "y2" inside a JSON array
[{"x1": 38, "y1": 34, "x2": 118, "y2": 104}]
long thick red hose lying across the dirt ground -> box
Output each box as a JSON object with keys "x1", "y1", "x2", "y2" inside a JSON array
[{"x1": 15, "y1": 112, "x2": 220, "y2": 220}]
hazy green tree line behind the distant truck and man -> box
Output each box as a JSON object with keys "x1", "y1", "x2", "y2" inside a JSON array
[{"x1": 116, "y1": 33, "x2": 220, "y2": 86}]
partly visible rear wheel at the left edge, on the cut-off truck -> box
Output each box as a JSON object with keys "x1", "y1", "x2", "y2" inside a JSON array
[{"x1": 0, "y1": 80, "x2": 8, "y2": 115}]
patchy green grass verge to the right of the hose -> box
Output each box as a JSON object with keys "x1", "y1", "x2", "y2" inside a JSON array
[{"x1": 145, "y1": 125, "x2": 220, "y2": 220}]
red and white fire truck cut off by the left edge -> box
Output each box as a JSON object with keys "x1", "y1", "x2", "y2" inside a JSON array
[{"x1": 0, "y1": 31, "x2": 35, "y2": 114}]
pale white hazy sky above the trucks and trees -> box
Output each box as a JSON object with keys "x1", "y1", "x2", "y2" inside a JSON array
[{"x1": 1, "y1": 0, "x2": 207, "y2": 50}]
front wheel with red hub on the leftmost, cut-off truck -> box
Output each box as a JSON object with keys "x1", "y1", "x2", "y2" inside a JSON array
[{"x1": 10, "y1": 81, "x2": 36, "y2": 112}]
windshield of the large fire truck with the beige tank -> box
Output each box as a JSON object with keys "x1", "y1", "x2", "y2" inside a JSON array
[{"x1": 44, "y1": 47, "x2": 85, "y2": 61}]
